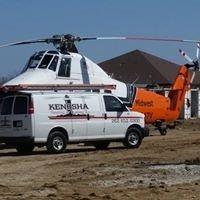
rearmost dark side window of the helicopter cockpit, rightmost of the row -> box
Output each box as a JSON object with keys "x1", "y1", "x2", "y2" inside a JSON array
[{"x1": 58, "y1": 58, "x2": 71, "y2": 77}]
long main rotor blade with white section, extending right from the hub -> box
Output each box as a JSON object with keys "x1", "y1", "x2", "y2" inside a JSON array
[{"x1": 80, "y1": 36, "x2": 200, "y2": 43}]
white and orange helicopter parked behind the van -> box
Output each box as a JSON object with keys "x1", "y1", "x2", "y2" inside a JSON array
[{"x1": 0, "y1": 34, "x2": 200, "y2": 135}]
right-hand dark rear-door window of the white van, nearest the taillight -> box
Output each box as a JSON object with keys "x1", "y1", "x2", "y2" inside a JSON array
[{"x1": 14, "y1": 96, "x2": 28, "y2": 114}]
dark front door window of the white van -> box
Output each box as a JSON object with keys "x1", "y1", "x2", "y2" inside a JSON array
[{"x1": 103, "y1": 96, "x2": 127, "y2": 112}]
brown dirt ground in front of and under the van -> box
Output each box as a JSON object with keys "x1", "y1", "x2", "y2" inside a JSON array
[{"x1": 0, "y1": 120, "x2": 200, "y2": 200}]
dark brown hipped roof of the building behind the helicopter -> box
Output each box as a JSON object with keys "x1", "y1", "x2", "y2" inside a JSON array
[{"x1": 99, "y1": 50, "x2": 200, "y2": 86}]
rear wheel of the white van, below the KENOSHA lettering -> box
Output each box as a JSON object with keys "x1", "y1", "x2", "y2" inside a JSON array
[{"x1": 46, "y1": 131, "x2": 67, "y2": 154}]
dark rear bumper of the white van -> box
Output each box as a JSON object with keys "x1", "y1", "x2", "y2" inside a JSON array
[{"x1": 0, "y1": 137, "x2": 34, "y2": 145}]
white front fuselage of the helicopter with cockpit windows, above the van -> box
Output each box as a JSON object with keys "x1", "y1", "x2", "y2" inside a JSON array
[{"x1": 4, "y1": 51, "x2": 130, "y2": 98}]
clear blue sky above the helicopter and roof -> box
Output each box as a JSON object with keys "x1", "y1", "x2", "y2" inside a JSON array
[{"x1": 0, "y1": 0, "x2": 200, "y2": 76}]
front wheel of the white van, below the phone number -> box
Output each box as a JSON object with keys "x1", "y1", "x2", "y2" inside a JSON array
[{"x1": 123, "y1": 127, "x2": 142, "y2": 148}]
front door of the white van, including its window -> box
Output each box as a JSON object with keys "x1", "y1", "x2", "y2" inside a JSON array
[{"x1": 103, "y1": 95, "x2": 130, "y2": 138}]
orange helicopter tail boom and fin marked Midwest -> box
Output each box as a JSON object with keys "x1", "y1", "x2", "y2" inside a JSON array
[{"x1": 131, "y1": 66, "x2": 192, "y2": 123}]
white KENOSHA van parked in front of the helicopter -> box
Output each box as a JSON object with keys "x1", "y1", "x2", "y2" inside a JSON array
[{"x1": 0, "y1": 91, "x2": 148, "y2": 153}]
